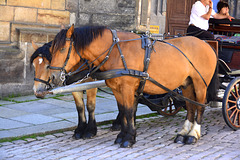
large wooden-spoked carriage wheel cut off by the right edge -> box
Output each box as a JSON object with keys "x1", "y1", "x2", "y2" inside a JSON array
[{"x1": 222, "y1": 77, "x2": 240, "y2": 130}]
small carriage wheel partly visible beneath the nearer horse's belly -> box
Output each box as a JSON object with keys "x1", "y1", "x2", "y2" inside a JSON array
[{"x1": 157, "y1": 98, "x2": 182, "y2": 116}]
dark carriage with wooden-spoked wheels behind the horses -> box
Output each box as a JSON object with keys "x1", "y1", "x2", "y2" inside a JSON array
[{"x1": 140, "y1": 19, "x2": 240, "y2": 130}]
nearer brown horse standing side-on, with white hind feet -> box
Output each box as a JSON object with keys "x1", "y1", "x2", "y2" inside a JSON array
[{"x1": 50, "y1": 25, "x2": 217, "y2": 147}]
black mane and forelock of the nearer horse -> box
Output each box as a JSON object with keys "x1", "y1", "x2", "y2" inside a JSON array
[{"x1": 52, "y1": 26, "x2": 106, "y2": 52}]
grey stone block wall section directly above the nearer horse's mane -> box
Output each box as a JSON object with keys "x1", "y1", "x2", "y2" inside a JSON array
[{"x1": 77, "y1": 0, "x2": 136, "y2": 31}]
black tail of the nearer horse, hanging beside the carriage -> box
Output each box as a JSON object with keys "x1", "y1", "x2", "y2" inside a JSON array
[{"x1": 207, "y1": 62, "x2": 219, "y2": 103}]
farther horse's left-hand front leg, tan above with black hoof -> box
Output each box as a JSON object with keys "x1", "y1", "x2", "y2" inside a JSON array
[{"x1": 72, "y1": 92, "x2": 87, "y2": 139}]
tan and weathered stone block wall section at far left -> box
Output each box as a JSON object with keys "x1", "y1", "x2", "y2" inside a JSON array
[{"x1": 0, "y1": 0, "x2": 71, "y2": 98}]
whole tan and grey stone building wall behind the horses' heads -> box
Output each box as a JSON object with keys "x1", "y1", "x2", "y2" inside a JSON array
[{"x1": 0, "y1": 0, "x2": 138, "y2": 98}]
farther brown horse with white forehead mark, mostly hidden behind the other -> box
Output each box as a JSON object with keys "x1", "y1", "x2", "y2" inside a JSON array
[{"x1": 30, "y1": 42, "x2": 119, "y2": 139}]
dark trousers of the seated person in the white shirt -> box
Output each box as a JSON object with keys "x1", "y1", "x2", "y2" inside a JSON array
[{"x1": 187, "y1": 25, "x2": 214, "y2": 40}]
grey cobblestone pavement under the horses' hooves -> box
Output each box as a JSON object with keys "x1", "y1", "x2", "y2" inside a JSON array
[{"x1": 0, "y1": 108, "x2": 240, "y2": 160}]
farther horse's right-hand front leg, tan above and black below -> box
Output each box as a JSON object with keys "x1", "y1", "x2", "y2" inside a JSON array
[{"x1": 84, "y1": 88, "x2": 97, "y2": 138}]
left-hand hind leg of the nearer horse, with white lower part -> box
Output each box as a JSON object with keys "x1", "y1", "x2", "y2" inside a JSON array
[{"x1": 174, "y1": 84, "x2": 196, "y2": 144}]
